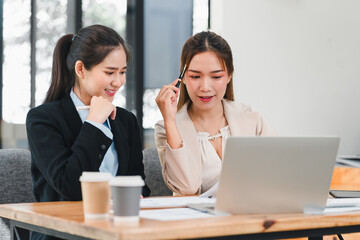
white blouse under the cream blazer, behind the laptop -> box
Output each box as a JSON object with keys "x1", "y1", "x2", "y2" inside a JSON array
[{"x1": 197, "y1": 126, "x2": 230, "y2": 193}]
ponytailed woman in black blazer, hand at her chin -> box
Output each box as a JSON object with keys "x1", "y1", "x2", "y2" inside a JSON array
[{"x1": 26, "y1": 25, "x2": 150, "y2": 206}]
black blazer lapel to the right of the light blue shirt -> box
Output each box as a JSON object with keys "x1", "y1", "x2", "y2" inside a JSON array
[{"x1": 109, "y1": 114, "x2": 130, "y2": 175}]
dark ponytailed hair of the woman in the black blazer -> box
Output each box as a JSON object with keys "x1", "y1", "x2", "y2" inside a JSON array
[{"x1": 44, "y1": 25, "x2": 130, "y2": 103}]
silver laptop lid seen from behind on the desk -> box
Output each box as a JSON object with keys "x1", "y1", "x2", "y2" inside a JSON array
[{"x1": 190, "y1": 136, "x2": 340, "y2": 214}]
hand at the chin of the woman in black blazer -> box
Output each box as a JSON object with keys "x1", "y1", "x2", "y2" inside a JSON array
[{"x1": 87, "y1": 96, "x2": 116, "y2": 124}]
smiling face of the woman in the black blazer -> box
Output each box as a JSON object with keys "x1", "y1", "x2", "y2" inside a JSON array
[{"x1": 74, "y1": 47, "x2": 127, "y2": 105}]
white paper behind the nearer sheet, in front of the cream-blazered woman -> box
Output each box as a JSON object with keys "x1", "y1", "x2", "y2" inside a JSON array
[{"x1": 140, "y1": 197, "x2": 216, "y2": 208}]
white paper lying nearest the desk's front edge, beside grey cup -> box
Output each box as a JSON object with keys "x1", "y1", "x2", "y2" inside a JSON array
[{"x1": 140, "y1": 208, "x2": 215, "y2": 221}]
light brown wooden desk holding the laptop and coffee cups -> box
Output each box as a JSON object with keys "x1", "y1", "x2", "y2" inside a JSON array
[{"x1": 0, "y1": 202, "x2": 360, "y2": 240}]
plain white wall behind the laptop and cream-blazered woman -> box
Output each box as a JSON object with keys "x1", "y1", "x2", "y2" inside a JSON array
[{"x1": 211, "y1": 0, "x2": 360, "y2": 154}]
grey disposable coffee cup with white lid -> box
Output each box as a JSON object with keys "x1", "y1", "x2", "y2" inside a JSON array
[{"x1": 110, "y1": 176, "x2": 145, "y2": 222}]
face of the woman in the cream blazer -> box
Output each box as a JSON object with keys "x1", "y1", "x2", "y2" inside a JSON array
[{"x1": 183, "y1": 51, "x2": 230, "y2": 111}]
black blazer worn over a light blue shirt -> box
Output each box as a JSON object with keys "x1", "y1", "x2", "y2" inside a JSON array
[{"x1": 26, "y1": 95, "x2": 150, "y2": 202}]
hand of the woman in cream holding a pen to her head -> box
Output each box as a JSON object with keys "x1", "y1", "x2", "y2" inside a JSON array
[{"x1": 155, "y1": 79, "x2": 180, "y2": 122}]
